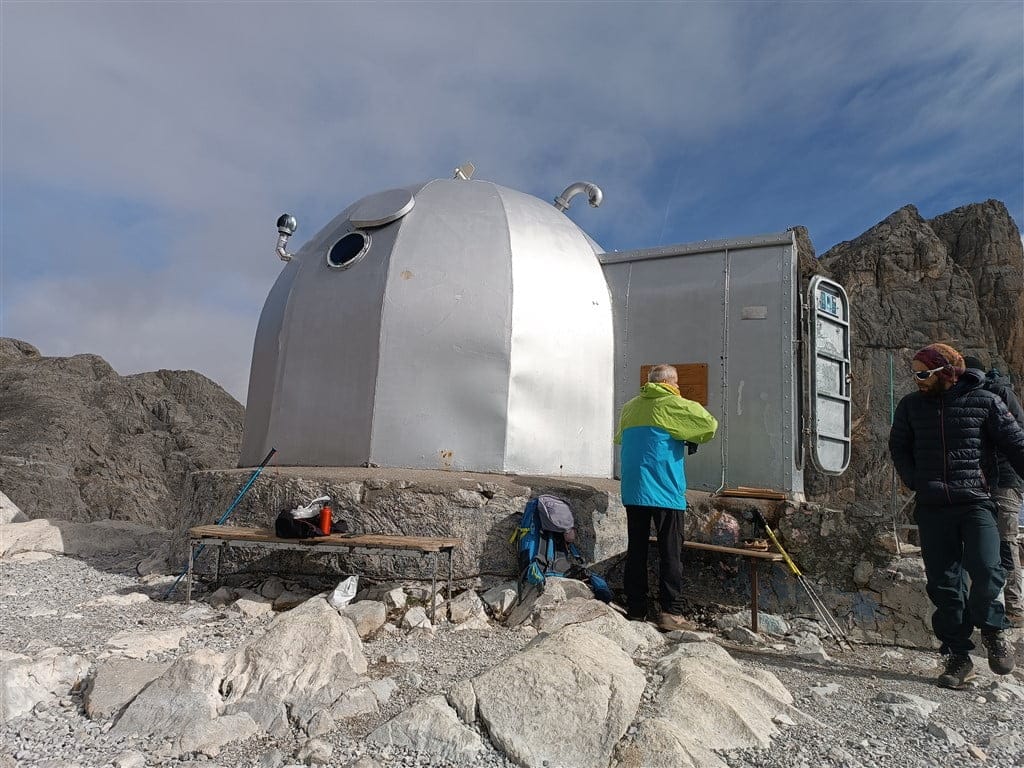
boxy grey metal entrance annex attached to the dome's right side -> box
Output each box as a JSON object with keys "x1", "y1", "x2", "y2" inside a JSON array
[{"x1": 599, "y1": 231, "x2": 803, "y2": 498}]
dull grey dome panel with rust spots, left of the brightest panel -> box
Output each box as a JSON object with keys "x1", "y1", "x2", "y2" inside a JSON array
[{"x1": 365, "y1": 181, "x2": 512, "y2": 472}]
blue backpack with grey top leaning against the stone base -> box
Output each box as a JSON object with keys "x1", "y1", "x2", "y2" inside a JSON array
[{"x1": 510, "y1": 494, "x2": 612, "y2": 602}]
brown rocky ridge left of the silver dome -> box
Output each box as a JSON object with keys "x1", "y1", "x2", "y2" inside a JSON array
[{"x1": 0, "y1": 339, "x2": 245, "y2": 525}]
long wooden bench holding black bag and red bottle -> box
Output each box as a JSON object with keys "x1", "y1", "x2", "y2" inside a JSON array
[{"x1": 185, "y1": 525, "x2": 462, "y2": 622}]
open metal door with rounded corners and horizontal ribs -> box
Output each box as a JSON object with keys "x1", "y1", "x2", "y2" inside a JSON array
[{"x1": 805, "y1": 275, "x2": 852, "y2": 475}]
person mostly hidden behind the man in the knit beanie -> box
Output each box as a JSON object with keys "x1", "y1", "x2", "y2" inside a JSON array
[{"x1": 964, "y1": 355, "x2": 1024, "y2": 627}]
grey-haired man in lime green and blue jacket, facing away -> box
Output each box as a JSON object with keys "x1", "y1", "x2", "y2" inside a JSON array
[{"x1": 615, "y1": 365, "x2": 718, "y2": 631}]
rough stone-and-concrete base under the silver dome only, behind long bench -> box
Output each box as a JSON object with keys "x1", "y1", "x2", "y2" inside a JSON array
[{"x1": 172, "y1": 467, "x2": 626, "y2": 586}]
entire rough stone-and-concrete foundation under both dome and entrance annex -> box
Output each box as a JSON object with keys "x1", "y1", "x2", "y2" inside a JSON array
[{"x1": 172, "y1": 467, "x2": 930, "y2": 645}]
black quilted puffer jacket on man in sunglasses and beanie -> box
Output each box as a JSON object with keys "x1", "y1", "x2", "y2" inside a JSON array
[{"x1": 889, "y1": 370, "x2": 1024, "y2": 504}]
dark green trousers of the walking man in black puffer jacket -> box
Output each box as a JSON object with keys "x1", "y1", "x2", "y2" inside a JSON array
[{"x1": 914, "y1": 501, "x2": 1010, "y2": 653}]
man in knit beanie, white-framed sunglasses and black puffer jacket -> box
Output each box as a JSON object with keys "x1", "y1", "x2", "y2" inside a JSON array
[{"x1": 889, "y1": 344, "x2": 1024, "y2": 688}]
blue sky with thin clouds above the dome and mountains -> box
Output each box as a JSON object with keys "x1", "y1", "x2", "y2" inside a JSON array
[{"x1": 0, "y1": 0, "x2": 1024, "y2": 400}]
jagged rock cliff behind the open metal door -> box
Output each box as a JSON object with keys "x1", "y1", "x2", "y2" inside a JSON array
[{"x1": 780, "y1": 200, "x2": 1024, "y2": 583}]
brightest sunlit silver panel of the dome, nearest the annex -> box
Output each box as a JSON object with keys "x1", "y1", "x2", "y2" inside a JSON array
[{"x1": 501, "y1": 188, "x2": 613, "y2": 477}]
